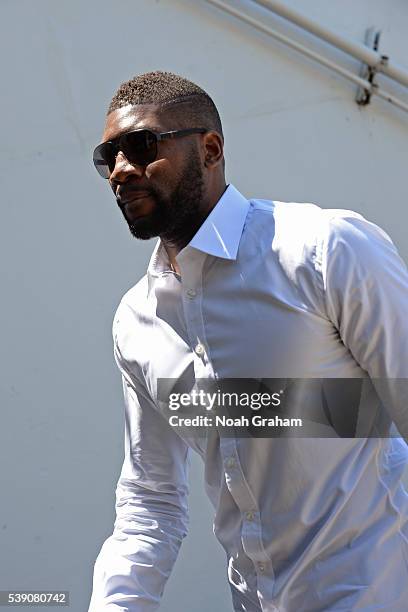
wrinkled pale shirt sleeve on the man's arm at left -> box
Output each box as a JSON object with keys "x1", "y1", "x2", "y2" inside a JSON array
[{"x1": 88, "y1": 318, "x2": 188, "y2": 612}]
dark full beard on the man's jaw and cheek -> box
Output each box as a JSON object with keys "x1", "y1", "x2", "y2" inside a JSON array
[{"x1": 121, "y1": 148, "x2": 207, "y2": 245}]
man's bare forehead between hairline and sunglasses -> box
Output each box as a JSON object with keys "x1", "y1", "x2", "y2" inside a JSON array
[{"x1": 102, "y1": 104, "x2": 168, "y2": 142}]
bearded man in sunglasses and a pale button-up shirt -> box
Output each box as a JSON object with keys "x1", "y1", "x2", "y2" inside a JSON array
[{"x1": 90, "y1": 72, "x2": 408, "y2": 612}]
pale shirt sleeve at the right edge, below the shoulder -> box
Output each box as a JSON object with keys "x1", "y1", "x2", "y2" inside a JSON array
[{"x1": 322, "y1": 211, "x2": 408, "y2": 441}]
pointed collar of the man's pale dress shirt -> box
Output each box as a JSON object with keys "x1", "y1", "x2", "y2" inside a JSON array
[{"x1": 147, "y1": 184, "x2": 249, "y2": 285}]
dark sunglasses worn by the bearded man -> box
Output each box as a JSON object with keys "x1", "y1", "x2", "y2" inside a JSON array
[{"x1": 93, "y1": 128, "x2": 208, "y2": 179}]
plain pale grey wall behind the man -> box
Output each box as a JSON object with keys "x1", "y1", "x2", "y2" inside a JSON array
[{"x1": 0, "y1": 0, "x2": 408, "y2": 612}]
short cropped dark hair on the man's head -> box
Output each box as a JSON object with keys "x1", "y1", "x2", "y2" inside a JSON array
[{"x1": 107, "y1": 70, "x2": 224, "y2": 138}]
